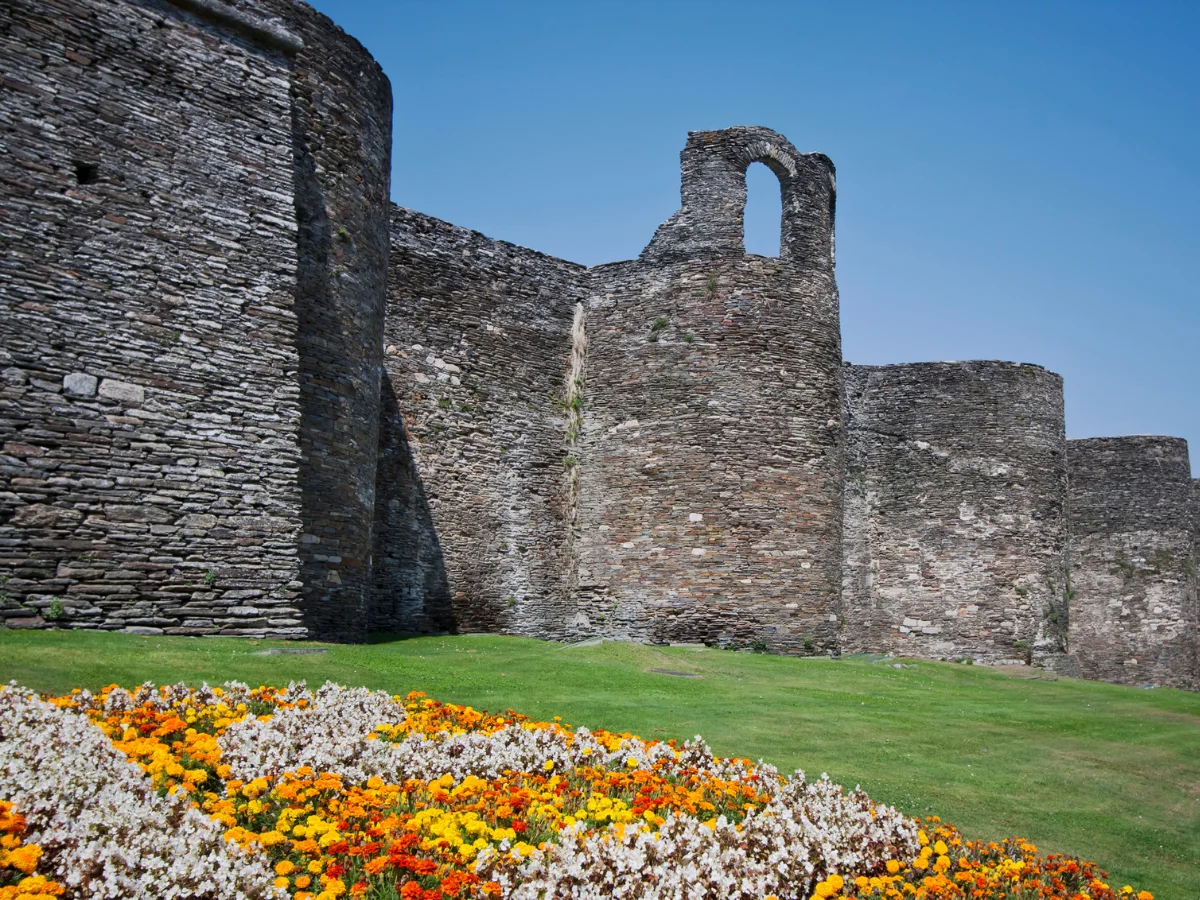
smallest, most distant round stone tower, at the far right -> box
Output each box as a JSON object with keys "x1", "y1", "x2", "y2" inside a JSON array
[{"x1": 1068, "y1": 437, "x2": 1200, "y2": 689}]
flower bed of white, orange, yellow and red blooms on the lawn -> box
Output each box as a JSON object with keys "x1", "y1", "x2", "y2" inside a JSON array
[{"x1": 0, "y1": 684, "x2": 1152, "y2": 900}]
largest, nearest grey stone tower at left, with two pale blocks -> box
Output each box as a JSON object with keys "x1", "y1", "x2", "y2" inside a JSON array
[{"x1": 0, "y1": 0, "x2": 390, "y2": 636}]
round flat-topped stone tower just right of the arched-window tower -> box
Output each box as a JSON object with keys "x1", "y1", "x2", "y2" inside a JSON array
[{"x1": 842, "y1": 362, "x2": 1067, "y2": 661}]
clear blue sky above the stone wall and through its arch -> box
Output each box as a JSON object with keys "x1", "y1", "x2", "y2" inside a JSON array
[{"x1": 304, "y1": 0, "x2": 1200, "y2": 470}]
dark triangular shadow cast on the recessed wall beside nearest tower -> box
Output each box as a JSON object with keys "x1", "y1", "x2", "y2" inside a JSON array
[{"x1": 370, "y1": 373, "x2": 458, "y2": 635}]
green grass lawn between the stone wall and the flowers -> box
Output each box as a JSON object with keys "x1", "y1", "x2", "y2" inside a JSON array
[{"x1": 0, "y1": 631, "x2": 1200, "y2": 900}]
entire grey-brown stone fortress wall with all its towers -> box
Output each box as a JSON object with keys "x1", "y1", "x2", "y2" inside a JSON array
[{"x1": 0, "y1": 0, "x2": 1200, "y2": 688}]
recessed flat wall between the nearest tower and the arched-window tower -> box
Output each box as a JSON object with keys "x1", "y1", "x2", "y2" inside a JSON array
[{"x1": 372, "y1": 208, "x2": 584, "y2": 636}]
